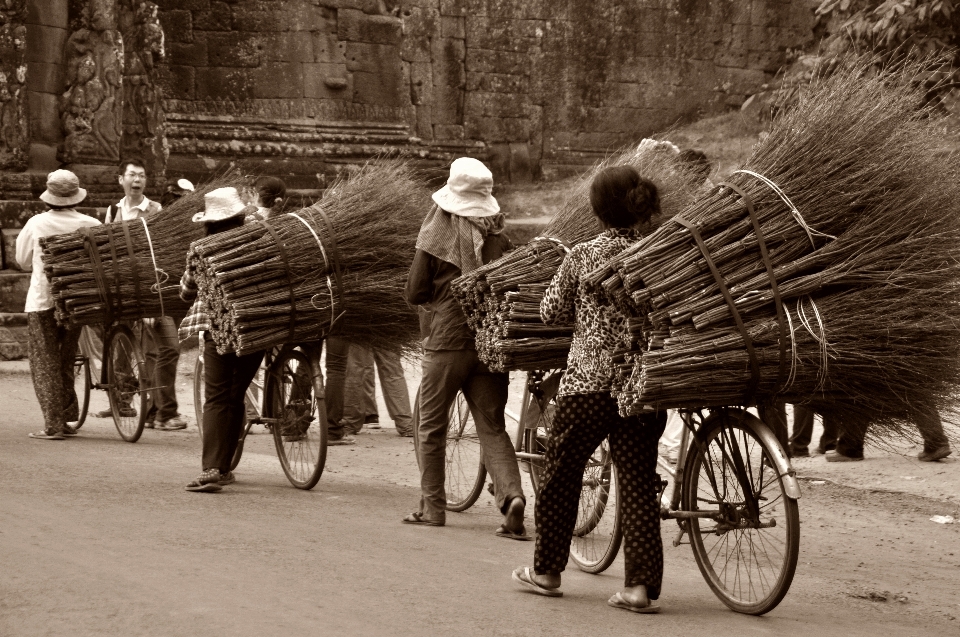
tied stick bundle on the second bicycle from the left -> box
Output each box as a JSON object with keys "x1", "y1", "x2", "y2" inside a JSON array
[{"x1": 188, "y1": 160, "x2": 430, "y2": 355}]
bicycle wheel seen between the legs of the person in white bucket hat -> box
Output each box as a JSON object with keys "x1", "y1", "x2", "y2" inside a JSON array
[{"x1": 444, "y1": 392, "x2": 487, "y2": 512}]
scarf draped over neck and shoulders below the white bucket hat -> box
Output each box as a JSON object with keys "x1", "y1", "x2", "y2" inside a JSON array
[{"x1": 417, "y1": 206, "x2": 504, "y2": 274}]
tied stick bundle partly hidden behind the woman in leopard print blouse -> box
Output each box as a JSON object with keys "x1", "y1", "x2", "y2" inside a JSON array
[{"x1": 452, "y1": 140, "x2": 702, "y2": 371}]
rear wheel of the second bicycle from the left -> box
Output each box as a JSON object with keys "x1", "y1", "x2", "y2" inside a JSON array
[{"x1": 264, "y1": 348, "x2": 327, "y2": 489}]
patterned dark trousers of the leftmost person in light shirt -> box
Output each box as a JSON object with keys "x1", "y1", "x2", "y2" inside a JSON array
[{"x1": 27, "y1": 309, "x2": 80, "y2": 432}]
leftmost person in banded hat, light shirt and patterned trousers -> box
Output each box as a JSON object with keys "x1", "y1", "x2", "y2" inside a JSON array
[{"x1": 16, "y1": 170, "x2": 100, "y2": 440}]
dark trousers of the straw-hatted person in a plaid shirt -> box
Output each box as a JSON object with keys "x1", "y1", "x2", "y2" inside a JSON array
[{"x1": 203, "y1": 338, "x2": 263, "y2": 473}]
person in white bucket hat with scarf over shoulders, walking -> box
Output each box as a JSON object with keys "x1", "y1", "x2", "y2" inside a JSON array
[{"x1": 403, "y1": 157, "x2": 530, "y2": 540}]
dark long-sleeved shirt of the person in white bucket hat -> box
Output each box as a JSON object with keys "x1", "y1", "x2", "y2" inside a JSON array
[{"x1": 404, "y1": 235, "x2": 510, "y2": 350}]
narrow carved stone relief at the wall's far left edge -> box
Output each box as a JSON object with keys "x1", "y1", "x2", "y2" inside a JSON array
[{"x1": 0, "y1": 0, "x2": 30, "y2": 170}]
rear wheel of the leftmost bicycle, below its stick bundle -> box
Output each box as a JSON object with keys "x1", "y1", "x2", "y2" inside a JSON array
[{"x1": 106, "y1": 325, "x2": 147, "y2": 442}]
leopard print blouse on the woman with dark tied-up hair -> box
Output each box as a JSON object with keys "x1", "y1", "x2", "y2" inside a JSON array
[{"x1": 540, "y1": 228, "x2": 640, "y2": 396}]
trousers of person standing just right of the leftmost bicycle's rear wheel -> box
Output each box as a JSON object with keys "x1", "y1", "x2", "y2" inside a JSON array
[{"x1": 141, "y1": 316, "x2": 180, "y2": 422}]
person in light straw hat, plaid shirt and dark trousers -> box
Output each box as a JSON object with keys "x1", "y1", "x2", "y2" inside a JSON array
[{"x1": 180, "y1": 187, "x2": 263, "y2": 493}]
